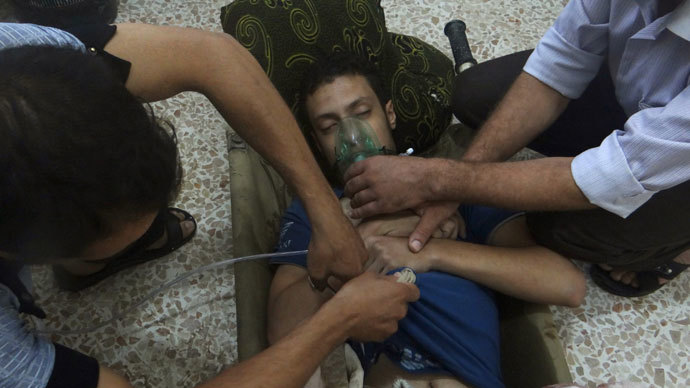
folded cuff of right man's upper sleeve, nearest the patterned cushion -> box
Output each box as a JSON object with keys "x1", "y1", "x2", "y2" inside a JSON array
[{"x1": 523, "y1": 27, "x2": 604, "y2": 99}]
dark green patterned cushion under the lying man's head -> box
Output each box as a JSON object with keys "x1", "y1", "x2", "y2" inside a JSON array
[{"x1": 221, "y1": 0, "x2": 453, "y2": 151}]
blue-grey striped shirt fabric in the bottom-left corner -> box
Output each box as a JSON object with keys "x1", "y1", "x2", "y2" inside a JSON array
[{"x1": 0, "y1": 276, "x2": 55, "y2": 388}]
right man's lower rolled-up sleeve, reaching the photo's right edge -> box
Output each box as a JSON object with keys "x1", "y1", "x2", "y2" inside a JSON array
[{"x1": 571, "y1": 86, "x2": 690, "y2": 217}]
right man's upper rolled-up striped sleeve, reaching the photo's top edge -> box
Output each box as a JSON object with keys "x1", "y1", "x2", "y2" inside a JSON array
[{"x1": 523, "y1": 0, "x2": 610, "y2": 99}]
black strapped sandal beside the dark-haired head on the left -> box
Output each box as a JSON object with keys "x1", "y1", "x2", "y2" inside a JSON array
[{"x1": 53, "y1": 207, "x2": 196, "y2": 292}]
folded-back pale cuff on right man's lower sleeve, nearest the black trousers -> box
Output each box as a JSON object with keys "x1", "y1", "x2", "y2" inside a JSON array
[{"x1": 570, "y1": 130, "x2": 656, "y2": 218}]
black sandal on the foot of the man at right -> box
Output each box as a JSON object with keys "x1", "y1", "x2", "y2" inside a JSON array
[{"x1": 589, "y1": 261, "x2": 690, "y2": 297}]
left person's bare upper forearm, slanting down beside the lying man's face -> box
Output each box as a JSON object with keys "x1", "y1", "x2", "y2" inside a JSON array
[{"x1": 191, "y1": 35, "x2": 344, "y2": 221}]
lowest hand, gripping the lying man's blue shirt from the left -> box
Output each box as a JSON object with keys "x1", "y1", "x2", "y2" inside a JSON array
[{"x1": 324, "y1": 272, "x2": 419, "y2": 342}]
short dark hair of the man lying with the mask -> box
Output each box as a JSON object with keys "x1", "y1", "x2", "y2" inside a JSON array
[{"x1": 299, "y1": 51, "x2": 390, "y2": 120}]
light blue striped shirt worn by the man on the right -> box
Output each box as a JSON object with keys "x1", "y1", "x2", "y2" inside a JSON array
[{"x1": 524, "y1": 0, "x2": 690, "y2": 217}]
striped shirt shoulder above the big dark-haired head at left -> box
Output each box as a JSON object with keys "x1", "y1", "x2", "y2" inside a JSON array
[{"x1": 0, "y1": 23, "x2": 85, "y2": 51}]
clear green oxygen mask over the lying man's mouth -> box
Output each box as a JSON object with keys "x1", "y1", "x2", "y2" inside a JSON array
[{"x1": 335, "y1": 117, "x2": 389, "y2": 176}]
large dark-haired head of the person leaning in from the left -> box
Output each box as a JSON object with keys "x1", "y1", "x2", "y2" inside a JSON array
[{"x1": 0, "y1": 47, "x2": 182, "y2": 259}]
